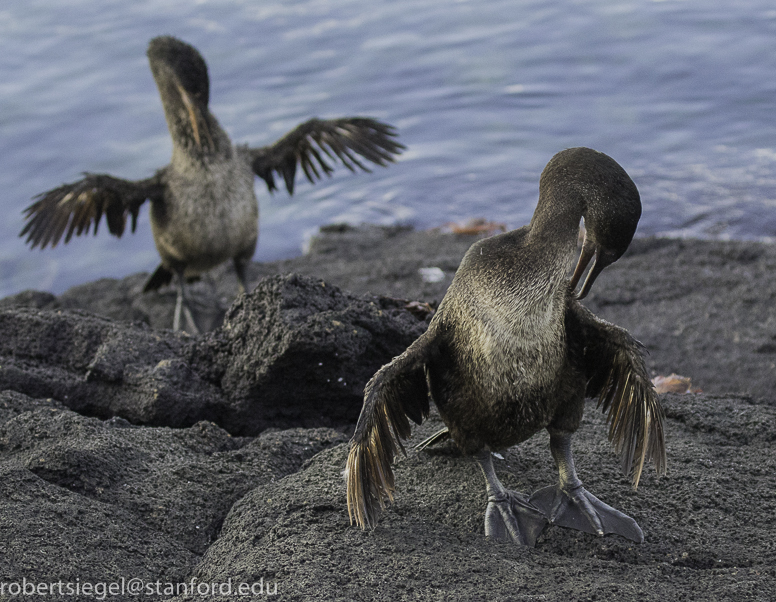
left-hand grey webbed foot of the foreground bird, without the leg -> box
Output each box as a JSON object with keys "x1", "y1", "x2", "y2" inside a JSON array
[{"x1": 485, "y1": 490, "x2": 547, "y2": 548}]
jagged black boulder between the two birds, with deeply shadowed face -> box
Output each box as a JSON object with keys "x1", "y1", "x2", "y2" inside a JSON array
[{"x1": 191, "y1": 274, "x2": 427, "y2": 434}]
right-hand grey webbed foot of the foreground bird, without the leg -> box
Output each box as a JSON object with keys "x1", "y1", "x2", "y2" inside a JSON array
[{"x1": 528, "y1": 484, "x2": 644, "y2": 543}]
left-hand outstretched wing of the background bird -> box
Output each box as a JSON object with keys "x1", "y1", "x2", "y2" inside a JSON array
[{"x1": 19, "y1": 170, "x2": 164, "y2": 249}]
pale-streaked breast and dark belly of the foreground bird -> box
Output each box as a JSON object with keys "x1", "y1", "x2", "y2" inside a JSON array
[{"x1": 429, "y1": 272, "x2": 567, "y2": 453}]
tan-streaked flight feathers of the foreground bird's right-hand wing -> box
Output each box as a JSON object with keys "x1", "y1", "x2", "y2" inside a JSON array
[{"x1": 598, "y1": 348, "x2": 666, "y2": 489}]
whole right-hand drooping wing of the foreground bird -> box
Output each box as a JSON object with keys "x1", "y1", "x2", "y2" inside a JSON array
[{"x1": 569, "y1": 301, "x2": 666, "y2": 488}]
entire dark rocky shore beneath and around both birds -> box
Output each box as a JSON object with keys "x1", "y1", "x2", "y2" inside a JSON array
[{"x1": 0, "y1": 226, "x2": 776, "y2": 601}]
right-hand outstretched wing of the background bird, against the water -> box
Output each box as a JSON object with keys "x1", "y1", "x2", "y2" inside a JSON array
[{"x1": 250, "y1": 117, "x2": 405, "y2": 194}]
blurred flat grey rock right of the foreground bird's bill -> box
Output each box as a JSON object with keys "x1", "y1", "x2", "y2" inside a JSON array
[{"x1": 587, "y1": 239, "x2": 776, "y2": 404}]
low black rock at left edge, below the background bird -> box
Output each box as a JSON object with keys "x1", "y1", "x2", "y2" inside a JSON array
[{"x1": 0, "y1": 308, "x2": 221, "y2": 426}]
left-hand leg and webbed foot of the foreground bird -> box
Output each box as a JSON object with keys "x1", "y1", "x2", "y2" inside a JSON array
[{"x1": 476, "y1": 448, "x2": 547, "y2": 548}]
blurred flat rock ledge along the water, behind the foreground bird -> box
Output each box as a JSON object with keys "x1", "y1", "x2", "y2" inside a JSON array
[{"x1": 6, "y1": 226, "x2": 776, "y2": 400}]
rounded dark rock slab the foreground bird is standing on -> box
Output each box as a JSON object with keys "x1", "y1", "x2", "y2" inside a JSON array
[{"x1": 171, "y1": 396, "x2": 776, "y2": 601}]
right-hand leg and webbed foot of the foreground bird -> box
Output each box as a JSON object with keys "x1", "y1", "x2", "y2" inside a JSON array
[{"x1": 529, "y1": 432, "x2": 644, "y2": 543}]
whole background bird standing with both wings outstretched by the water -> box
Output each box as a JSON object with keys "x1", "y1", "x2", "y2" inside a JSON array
[{"x1": 20, "y1": 36, "x2": 404, "y2": 330}]
